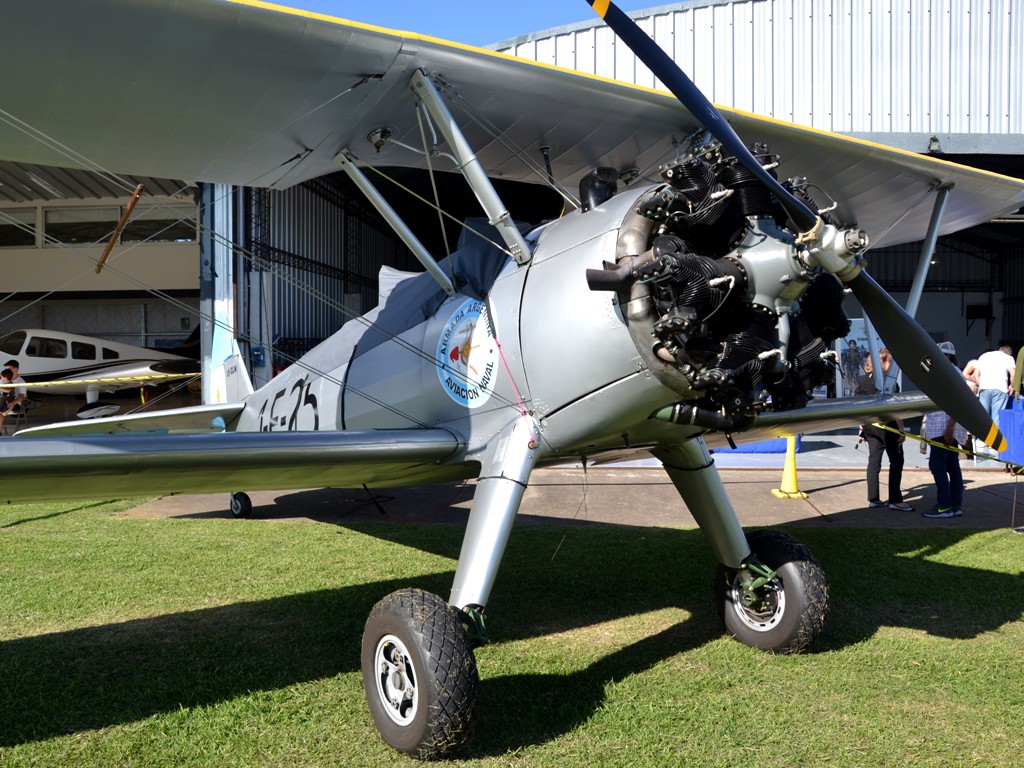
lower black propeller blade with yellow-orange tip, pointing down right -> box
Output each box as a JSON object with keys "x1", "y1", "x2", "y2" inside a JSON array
[{"x1": 847, "y1": 271, "x2": 1007, "y2": 452}]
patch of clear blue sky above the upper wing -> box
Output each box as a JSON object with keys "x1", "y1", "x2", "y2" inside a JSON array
[{"x1": 268, "y1": 0, "x2": 667, "y2": 45}]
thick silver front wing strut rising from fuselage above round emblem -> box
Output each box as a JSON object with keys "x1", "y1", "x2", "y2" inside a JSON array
[{"x1": 410, "y1": 70, "x2": 534, "y2": 264}]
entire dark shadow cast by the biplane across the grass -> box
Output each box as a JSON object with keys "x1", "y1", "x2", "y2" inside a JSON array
[{"x1": 0, "y1": 510, "x2": 1024, "y2": 756}]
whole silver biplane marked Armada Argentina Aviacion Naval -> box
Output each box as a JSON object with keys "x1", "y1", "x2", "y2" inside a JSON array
[{"x1": 0, "y1": 0, "x2": 1024, "y2": 758}]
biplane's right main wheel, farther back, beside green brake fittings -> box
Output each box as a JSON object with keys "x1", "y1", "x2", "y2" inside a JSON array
[{"x1": 715, "y1": 530, "x2": 828, "y2": 653}]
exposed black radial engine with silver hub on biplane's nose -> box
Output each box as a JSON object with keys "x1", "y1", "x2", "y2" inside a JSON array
[{"x1": 585, "y1": 143, "x2": 867, "y2": 428}]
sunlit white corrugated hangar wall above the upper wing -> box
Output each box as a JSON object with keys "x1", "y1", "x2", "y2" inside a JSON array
[{"x1": 496, "y1": 0, "x2": 1024, "y2": 134}]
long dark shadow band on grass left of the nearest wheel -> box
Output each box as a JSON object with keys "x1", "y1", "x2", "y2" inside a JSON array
[{"x1": 0, "y1": 574, "x2": 452, "y2": 746}]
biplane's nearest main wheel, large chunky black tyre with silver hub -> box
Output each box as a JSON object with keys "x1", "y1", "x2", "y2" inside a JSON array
[{"x1": 362, "y1": 589, "x2": 480, "y2": 760}]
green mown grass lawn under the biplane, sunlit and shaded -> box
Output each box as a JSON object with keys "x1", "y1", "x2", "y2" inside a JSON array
[{"x1": 0, "y1": 504, "x2": 1024, "y2": 768}]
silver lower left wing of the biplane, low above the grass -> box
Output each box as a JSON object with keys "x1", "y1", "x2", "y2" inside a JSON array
[{"x1": 0, "y1": 429, "x2": 460, "y2": 503}]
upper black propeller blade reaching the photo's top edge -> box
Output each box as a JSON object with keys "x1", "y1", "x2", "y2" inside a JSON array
[{"x1": 587, "y1": 0, "x2": 819, "y2": 233}]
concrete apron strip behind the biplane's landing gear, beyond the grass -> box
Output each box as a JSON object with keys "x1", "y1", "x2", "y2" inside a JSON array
[{"x1": 130, "y1": 429, "x2": 1024, "y2": 529}]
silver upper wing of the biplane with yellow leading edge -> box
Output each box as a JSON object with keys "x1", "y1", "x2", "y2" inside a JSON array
[{"x1": 0, "y1": 0, "x2": 1024, "y2": 245}]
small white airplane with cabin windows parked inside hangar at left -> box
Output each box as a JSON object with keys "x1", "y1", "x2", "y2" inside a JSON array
[{"x1": 0, "y1": 328, "x2": 200, "y2": 419}]
